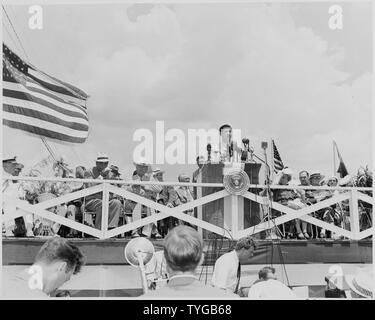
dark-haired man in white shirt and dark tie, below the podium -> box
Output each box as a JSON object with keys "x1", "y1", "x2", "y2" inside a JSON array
[{"x1": 211, "y1": 237, "x2": 255, "y2": 294}]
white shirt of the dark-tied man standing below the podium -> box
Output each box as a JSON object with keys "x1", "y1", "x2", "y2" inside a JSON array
[{"x1": 211, "y1": 250, "x2": 239, "y2": 292}]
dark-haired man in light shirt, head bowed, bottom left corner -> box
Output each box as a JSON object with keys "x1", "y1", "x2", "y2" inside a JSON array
[{"x1": 2, "y1": 237, "x2": 84, "y2": 299}]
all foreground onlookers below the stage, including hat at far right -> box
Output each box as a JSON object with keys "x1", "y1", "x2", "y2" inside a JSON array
[{"x1": 2, "y1": 225, "x2": 373, "y2": 300}]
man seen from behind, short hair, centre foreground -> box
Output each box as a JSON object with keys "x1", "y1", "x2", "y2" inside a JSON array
[{"x1": 143, "y1": 226, "x2": 238, "y2": 298}]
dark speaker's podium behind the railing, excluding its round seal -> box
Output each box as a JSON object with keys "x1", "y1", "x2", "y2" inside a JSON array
[{"x1": 197, "y1": 163, "x2": 261, "y2": 238}]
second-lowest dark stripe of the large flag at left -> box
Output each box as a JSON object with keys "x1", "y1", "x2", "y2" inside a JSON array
[{"x1": 3, "y1": 104, "x2": 89, "y2": 131}]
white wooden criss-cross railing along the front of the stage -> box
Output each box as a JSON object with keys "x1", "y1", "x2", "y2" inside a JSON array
[{"x1": 2, "y1": 177, "x2": 374, "y2": 240}]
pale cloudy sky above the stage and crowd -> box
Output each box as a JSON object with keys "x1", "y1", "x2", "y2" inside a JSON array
[{"x1": 3, "y1": 3, "x2": 372, "y2": 180}]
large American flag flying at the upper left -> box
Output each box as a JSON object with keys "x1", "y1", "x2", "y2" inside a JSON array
[{"x1": 3, "y1": 43, "x2": 89, "y2": 143}]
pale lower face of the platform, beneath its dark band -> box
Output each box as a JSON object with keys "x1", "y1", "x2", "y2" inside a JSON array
[{"x1": 2, "y1": 263, "x2": 368, "y2": 298}]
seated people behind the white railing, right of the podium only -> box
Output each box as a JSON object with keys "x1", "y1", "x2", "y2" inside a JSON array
[{"x1": 271, "y1": 168, "x2": 372, "y2": 239}]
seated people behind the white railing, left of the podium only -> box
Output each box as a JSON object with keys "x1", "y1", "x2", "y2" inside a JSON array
[{"x1": 3, "y1": 154, "x2": 200, "y2": 239}]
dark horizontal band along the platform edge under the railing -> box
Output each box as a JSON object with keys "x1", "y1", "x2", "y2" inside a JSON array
[{"x1": 2, "y1": 238, "x2": 372, "y2": 265}]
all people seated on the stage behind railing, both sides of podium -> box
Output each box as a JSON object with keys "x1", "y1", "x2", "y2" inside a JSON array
[{"x1": 3, "y1": 154, "x2": 372, "y2": 239}]
